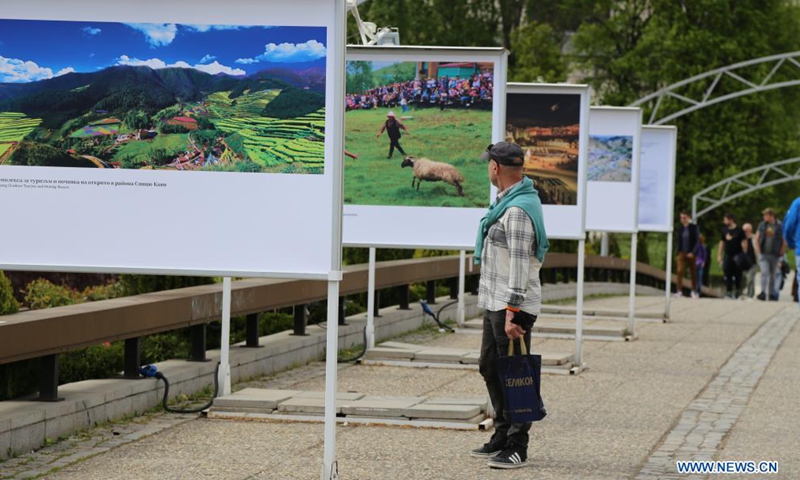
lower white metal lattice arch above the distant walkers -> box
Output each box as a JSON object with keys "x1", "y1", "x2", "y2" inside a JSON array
[{"x1": 692, "y1": 157, "x2": 800, "y2": 221}]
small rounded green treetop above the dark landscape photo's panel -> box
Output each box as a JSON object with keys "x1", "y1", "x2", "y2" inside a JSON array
[{"x1": 509, "y1": 22, "x2": 567, "y2": 83}]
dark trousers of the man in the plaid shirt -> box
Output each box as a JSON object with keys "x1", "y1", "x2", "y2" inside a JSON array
[{"x1": 479, "y1": 310, "x2": 536, "y2": 449}]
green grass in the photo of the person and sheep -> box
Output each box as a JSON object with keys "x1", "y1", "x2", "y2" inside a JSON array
[{"x1": 344, "y1": 108, "x2": 492, "y2": 208}]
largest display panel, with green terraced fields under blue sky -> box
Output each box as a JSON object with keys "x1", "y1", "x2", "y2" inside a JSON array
[{"x1": 0, "y1": 0, "x2": 344, "y2": 278}]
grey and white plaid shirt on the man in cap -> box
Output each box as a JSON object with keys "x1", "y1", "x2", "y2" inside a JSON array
[{"x1": 478, "y1": 182, "x2": 542, "y2": 315}]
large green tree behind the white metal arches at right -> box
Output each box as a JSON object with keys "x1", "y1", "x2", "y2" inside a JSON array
[{"x1": 574, "y1": 0, "x2": 800, "y2": 232}]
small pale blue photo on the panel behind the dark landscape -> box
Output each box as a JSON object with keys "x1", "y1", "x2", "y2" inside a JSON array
[{"x1": 586, "y1": 135, "x2": 633, "y2": 182}]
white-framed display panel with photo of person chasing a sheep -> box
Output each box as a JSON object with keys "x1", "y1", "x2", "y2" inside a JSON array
[{"x1": 343, "y1": 47, "x2": 506, "y2": 249}]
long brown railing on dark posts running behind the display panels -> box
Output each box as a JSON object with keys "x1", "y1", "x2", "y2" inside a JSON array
[{"x1": 0, "y1": 253, "x2": 684, "y2": 401}]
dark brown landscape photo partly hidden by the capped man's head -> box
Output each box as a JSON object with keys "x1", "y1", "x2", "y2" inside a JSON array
[{"x1": 506, "y1": 93, "x2": 581, "y2": 205}]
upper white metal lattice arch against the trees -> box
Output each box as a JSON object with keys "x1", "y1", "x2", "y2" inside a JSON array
[{"x1": 631, "y1": 52, "x2": 800, "y2": 125}]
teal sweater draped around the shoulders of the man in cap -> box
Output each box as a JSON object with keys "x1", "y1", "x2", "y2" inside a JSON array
[{"x1": 475, "y1": 177, "x2": 550, "y2": 265}]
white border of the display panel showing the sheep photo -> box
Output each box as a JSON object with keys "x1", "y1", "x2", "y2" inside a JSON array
[{"x1": 343, "y1": 46, "x2": 508, "y2": 251}]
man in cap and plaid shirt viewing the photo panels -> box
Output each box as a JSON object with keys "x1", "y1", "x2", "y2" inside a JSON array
[{"x1": 471, "y1": 142, "x2": 550, "y2": 468}]
